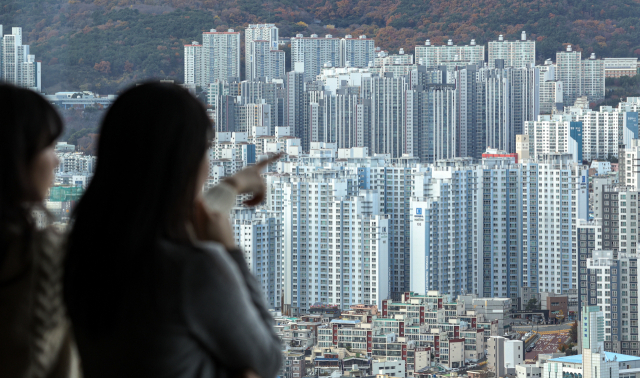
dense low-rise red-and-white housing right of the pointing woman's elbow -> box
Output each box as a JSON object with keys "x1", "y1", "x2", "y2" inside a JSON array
[{"x1": 275, "y1": 291, "x2": 511, "y2": 378}]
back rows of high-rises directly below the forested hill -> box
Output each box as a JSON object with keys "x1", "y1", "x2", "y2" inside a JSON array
[{"x1": 185, "y1": 24, "x2": 638, "y2": 173}]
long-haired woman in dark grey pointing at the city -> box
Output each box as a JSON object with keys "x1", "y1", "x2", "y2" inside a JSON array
[{"x1": 64, "y1": 83, "x2": 281, "y2": 378}]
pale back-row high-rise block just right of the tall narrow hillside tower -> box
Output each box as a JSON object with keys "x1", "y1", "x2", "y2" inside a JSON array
[{"x1": 291, "y1": 34, "x2": 342, "y2": 81}]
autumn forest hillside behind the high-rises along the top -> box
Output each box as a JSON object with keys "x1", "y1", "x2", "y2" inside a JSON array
[{"x1": 0, "y1": 0, "x2": 640, "y2": 94}]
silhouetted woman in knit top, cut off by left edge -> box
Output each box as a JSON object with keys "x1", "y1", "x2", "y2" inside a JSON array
[{"x1": 0, "y1": 84, "x2": 79, "y2": 378}]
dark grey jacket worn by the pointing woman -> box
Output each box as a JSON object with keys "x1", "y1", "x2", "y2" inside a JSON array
[{"x1": 72, "y1": 241, "x2": 282, "y2": 378}]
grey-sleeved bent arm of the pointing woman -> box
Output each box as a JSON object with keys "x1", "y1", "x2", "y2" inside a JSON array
[{"x1": 184, "y1": 243, "x2": 281, "y2": 378}]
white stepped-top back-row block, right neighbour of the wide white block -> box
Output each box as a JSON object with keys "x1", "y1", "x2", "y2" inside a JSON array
[{"x1": 488, "y1": 31, "x2": 536, "y2": 68}]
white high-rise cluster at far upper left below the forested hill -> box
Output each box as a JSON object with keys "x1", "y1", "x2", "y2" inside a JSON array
[{"x1": 0, "y1": 25, "x2": 41, "y2": 92}]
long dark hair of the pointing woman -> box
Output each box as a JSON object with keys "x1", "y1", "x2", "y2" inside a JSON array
[{"x1": 64, "y1": 83, "x2": 213, "y2": 332}]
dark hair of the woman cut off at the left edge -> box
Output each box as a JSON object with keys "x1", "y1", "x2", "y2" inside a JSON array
[{"x1": 0, "y1": 84, "x2": 62, "y2": 272}]
